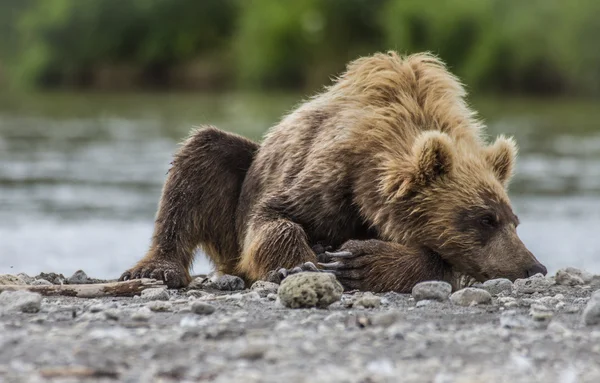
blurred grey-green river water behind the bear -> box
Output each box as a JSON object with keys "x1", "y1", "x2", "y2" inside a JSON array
[{"x1": 0, "y1": 93, "x2": 600, "y2": 278}]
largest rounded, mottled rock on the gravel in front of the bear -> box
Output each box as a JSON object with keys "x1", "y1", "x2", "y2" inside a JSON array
[{"x1": 278, "y1": 272, "x2": 344, "y2": 308}]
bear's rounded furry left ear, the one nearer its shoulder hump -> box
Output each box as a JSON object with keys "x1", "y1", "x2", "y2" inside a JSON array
[{"x1": 413, "y1": 130, "x2": 454, "y2": 186}]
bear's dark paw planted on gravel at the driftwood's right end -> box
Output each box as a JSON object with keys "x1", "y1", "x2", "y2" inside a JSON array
[{"x1": 119, "y1": 260, "x2": 191, "y2": 289}]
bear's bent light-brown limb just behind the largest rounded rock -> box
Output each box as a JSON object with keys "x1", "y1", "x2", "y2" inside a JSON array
[{"x1": 238, "y1": 218, "x2": 317, "y2": 281}]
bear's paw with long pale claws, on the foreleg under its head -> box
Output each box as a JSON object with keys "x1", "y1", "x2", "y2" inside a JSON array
[{"x1": 319, "y1": 251, "x2": 372, "y2": 290}]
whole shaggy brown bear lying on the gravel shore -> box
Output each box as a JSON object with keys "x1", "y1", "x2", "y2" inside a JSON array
[{"x1": 121, "y1": 52, "x2": 546, "y2": 292}]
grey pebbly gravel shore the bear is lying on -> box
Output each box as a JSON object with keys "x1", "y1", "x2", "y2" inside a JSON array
[{"x1": 0, "y1": 269, "x2": 600, "y2": 383}]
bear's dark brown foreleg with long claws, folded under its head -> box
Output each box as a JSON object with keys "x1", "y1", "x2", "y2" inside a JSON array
[{"x1": 319, "y1": 239, "x2": 452, "y2": 293}]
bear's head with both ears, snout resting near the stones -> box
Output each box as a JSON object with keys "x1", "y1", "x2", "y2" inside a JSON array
[{"x1": 382, "y1": 131, "x2": 546, "y2": 281}]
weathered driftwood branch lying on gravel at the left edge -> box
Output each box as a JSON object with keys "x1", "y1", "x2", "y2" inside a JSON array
[{"x1": 0, "y1": 278, "x2": 167, "y2": 298}]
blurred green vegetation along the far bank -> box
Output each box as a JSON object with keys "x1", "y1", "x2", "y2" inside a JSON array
[{"x1": 0, "y1": 0, "x2": 600, "y2": 95}]
